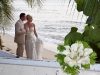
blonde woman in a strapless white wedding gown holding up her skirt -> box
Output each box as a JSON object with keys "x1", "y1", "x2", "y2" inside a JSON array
[{"x1": 24, "y1": 15, "x2": 42, "y2": 60}]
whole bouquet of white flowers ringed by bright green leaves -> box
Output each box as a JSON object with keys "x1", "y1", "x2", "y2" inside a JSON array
[{"x1": 55, "y1": 42, "x2": 97, "y2": 75}]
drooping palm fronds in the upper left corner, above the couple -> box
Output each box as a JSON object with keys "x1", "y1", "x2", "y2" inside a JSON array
[{"x1": 0, "y1": 0, "x2": 14, "y2": 29}]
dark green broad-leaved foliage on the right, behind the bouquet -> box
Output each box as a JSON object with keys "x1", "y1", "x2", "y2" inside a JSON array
[{"x1": 64, "y1": 0, "x2": 100, "y2": 61}]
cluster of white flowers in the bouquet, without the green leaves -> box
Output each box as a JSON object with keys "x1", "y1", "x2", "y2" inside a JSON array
[{"x1": 63, "y1": 43, "x2": 93, "y2": 67}]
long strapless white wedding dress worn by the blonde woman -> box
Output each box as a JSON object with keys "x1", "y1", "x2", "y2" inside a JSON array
[{"x1": 25, "y1": 27, "x2": 43, "y2": 60}]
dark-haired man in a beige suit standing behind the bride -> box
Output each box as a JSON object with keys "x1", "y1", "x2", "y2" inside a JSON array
[{"x1": 14, "y1": 13, "x2": 26, "y2": 58}]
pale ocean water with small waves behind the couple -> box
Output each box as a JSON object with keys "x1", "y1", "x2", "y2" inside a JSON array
[{"x1": 6, "y1": 0, "x2": 87, "y2": 44}]
